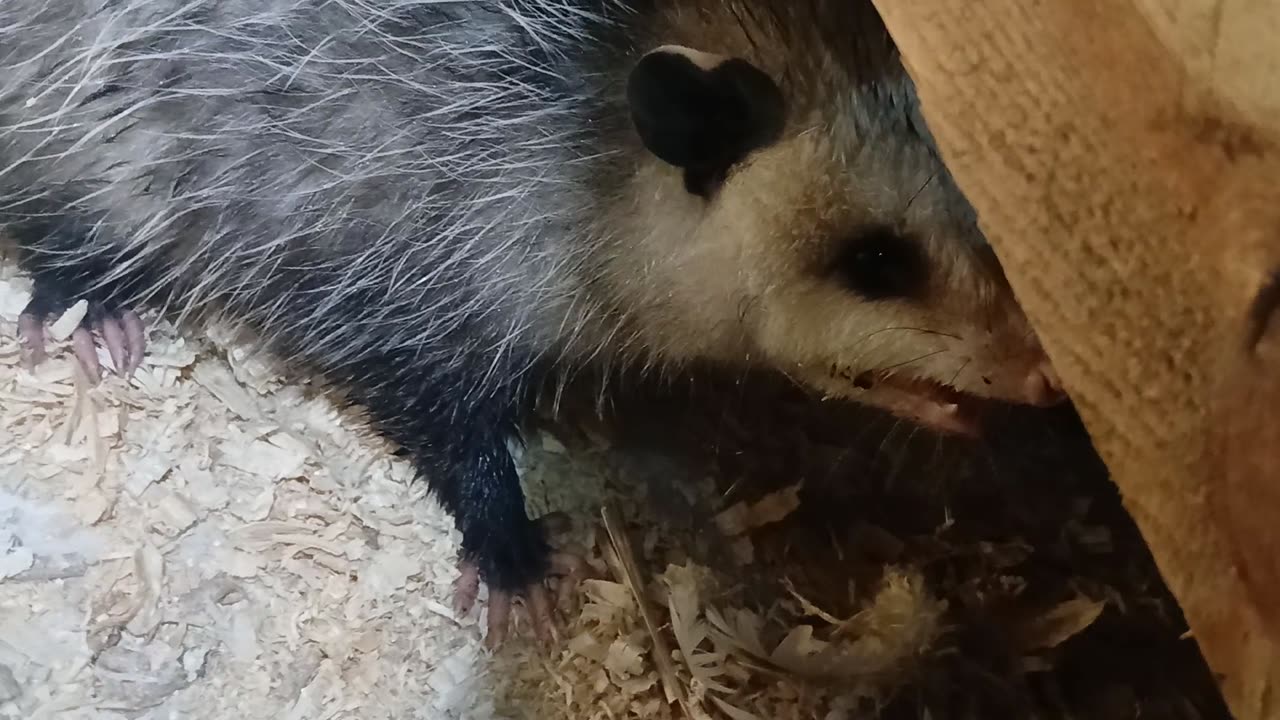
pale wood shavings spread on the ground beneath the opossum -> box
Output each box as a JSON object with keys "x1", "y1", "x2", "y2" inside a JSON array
[{"x1": 0, "y1": 248, "x2": 945, "y2": 720}]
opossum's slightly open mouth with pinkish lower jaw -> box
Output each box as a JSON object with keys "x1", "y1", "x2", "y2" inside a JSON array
[{"x1": 854, "y1": 372, "x2": 982, "y2": 437}]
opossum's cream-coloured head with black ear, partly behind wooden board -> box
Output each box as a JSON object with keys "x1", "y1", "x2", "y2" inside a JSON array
[{"x1": 614, "y1": 4, "x2": 1064, "y2": 433}]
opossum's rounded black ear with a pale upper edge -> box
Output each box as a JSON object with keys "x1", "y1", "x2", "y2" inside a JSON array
[{"x1": 627, "y1": 45, "x2": 786, "y2": 197}]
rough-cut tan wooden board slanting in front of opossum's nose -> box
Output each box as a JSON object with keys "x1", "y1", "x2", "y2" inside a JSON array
[{"x1": 876, "y1": 0, "x2": 1280, "y2": 720}]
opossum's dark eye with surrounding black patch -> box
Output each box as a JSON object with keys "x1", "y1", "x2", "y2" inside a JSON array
[{"x1": 836, "y1": 225, "x2": 929, "y2": 300}]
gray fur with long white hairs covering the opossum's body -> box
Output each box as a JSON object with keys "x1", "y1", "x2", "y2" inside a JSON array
[{"x1": 0, "y1": 0, "x2": 640, "y2": 372}]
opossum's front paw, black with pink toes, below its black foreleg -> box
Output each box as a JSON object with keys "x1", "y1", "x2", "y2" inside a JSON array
[{"x1": 453, "y1": 512, "x2": 588, "y2": 648}]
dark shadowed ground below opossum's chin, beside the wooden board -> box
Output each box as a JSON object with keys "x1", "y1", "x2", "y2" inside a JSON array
[{"x1": 537, "y1": 373, "x2": 1229, "y2": 720}]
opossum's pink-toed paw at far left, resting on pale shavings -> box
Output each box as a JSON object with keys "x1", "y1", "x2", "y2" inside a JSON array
[{"x1": 18, "y1": 283, "x2": 146, "y2": 383}]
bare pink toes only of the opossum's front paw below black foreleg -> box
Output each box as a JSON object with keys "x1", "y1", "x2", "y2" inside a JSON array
[{"x1": 453, "y1": 514, "x2": 588, "y2": 650}]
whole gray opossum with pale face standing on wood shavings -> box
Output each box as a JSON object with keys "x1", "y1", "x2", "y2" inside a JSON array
[{"x1": 0, "y1": 0, "x2": 1064, "y2": 637}]
